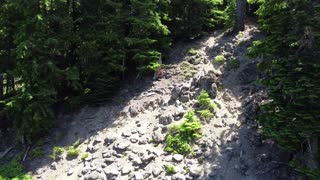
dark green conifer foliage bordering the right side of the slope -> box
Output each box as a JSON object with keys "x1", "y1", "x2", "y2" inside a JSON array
[{"x1": 249, "y1": 0, "x2": 320, "y2": 179}]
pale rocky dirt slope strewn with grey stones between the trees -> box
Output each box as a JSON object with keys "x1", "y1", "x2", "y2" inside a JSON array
[{"x1": 28, "y1": 25, "x2": 289, "y2": 180}]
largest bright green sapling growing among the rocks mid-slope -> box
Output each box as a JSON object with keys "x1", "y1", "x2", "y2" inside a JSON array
[{"x1": 165, "y1": 111, "x2": 202, "y2": 155}]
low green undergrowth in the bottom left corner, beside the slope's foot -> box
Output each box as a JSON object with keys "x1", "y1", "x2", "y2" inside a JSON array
[{"x1": 0, "y1": 158, "x2": 33, "y2": 180}]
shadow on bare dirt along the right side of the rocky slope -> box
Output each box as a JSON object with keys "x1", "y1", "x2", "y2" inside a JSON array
[{"x1": 200, "y1": 24, "x2": 296, "y2": 180}]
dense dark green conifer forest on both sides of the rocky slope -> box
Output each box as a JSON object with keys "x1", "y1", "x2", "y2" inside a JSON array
[{"x1": 0, "y1": 0, "x2": 320, "y2": 177}]
